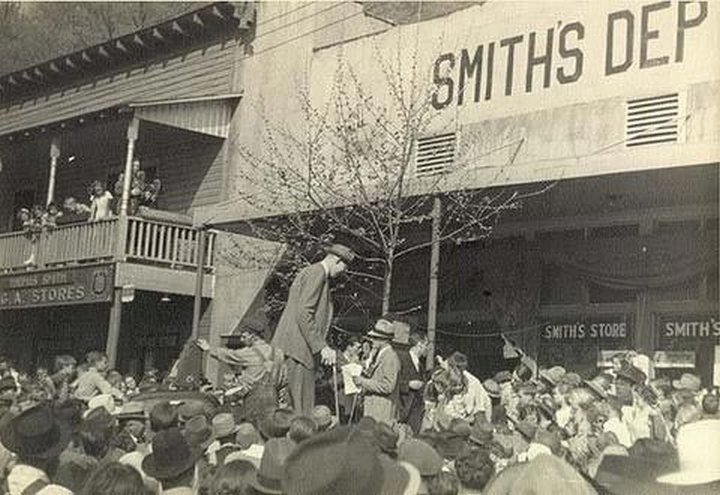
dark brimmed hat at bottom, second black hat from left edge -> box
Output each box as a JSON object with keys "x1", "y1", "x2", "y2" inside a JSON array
[{"x1": 142, "y1": 428, "x2": 202, "y2": 481}]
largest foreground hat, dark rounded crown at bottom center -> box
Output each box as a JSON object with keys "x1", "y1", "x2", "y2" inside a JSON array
[{"x1": 282, "y1": 427, "x2": 386, "y2": 495}]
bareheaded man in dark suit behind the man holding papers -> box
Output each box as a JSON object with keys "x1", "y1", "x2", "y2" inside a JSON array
[{"x1": 398, "y1": 332, "x2": 427, "y2": 434}]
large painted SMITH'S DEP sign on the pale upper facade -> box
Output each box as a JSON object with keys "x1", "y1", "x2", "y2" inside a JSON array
[{"x1": 432, "y1": 1, "x2": 720, "y2": 110}]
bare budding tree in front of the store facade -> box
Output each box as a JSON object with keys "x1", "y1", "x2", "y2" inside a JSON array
[{"x1": 225, "y1": 48, "x2": 546, "y2": 320}]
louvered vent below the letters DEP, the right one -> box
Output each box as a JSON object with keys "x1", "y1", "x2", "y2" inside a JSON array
[{"x1": 625, "y1": 93, "x2": 684, "y2": 148}]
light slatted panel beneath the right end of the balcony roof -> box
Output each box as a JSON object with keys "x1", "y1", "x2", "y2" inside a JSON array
[{"x1": 128, "y1": 94, "x2": 242, "y2": 138}]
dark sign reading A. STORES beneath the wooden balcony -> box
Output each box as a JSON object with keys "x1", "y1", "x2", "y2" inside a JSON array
[{"x1": 0, "y1": 265, "x2": 114, "y2": 310}]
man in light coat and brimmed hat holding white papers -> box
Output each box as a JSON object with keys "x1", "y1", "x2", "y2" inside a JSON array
[{"x1": 354, "y1": 319, "x2": 400, "y2": 426}]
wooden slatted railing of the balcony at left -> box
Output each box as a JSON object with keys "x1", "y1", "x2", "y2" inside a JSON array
[{"x1": 0, "y1": 217, "x2": 215, "y2": 272}]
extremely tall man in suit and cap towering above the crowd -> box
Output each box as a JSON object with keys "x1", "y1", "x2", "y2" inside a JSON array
[{"x1": 271, "y1": 244, "x2": 356, "y2": 416}]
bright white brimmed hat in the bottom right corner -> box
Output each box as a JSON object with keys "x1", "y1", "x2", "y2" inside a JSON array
[{"x1": 657, "y1": 419, "x2": 720, "y2": 485}]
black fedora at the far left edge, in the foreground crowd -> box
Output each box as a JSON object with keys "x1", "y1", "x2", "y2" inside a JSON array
[{"x1": 0, "y1": 404, "x2": 71, "y2": 459}]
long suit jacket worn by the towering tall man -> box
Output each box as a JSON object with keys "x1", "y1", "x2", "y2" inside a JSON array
[{"x1": 271, "y1": 263, "x2": 333, "y2": 369}]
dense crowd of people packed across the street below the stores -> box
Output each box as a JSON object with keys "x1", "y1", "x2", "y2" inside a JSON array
[{"x1": 0, "y1": 315, "x2": 720, "y2": 495}]
